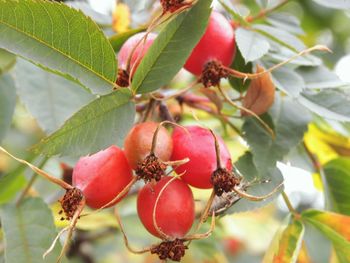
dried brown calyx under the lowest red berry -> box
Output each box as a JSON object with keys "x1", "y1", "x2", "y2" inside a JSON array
[{"x1": 151, "y1": 239, "x2": 188, "y2": 261}]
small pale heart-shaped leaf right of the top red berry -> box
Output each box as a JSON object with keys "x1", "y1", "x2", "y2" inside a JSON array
[{"x1": 236, "y1": 27, "x2": 270, "y2": 63}]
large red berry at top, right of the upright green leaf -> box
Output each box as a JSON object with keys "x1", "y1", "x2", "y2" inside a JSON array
[{"x1": 184, "y1": 11, "x2": 236, "y2": 76}]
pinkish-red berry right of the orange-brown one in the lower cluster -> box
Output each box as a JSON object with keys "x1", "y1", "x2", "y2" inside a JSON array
[{"x1": 171, "y1": 126, "x2": 232, "y2": 189}]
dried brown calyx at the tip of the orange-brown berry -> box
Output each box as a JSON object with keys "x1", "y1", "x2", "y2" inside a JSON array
[{"x1": 135, "y1": 153, "x2": 167, "y2": 183}]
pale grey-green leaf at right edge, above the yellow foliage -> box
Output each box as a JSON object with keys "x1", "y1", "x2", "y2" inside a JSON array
[{"x1": 298, "y1": 89, "x2": 350, "y2": 122}]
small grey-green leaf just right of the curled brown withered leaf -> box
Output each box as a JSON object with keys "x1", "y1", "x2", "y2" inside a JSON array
[{"x1": 271, "y1": 68, "x2": 305, "y2": 98}]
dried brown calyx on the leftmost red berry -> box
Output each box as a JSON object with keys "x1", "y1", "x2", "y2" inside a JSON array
[{"x1": 59, "y1": 187, "x2": 84, "y2": 220}]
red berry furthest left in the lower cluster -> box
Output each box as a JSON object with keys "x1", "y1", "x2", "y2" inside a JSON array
[{"x1": 73, "y1": 146, "x2": 132, "y2": 209}]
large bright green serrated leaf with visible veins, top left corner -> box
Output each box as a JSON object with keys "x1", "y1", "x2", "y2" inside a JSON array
[{"x1": 0, "y1": 0, "x2": 117, "y2": 93}]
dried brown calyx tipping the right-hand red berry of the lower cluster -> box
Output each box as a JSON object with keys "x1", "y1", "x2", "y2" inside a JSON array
[{"x1": 211, "y1": 168, "x2": 240, "y2": 196}]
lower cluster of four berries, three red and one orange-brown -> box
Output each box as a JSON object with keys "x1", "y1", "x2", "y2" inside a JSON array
[{"x1": 73, "y1": 122, "x2": 232, "y2": 259}]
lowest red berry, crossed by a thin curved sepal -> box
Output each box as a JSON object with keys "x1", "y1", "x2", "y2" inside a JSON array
[{"x1": 137, "y1": 177, "x2": 195, "y2": 238}]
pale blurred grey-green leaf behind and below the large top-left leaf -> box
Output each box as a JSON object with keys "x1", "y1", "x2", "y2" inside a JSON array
[{"x1": 16, "y1": 59, "x2": 95, "y2": 133}]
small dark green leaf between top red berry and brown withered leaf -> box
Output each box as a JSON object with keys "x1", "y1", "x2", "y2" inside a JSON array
[{"x1": 228, "y1": 49, "x2": 253, "y2": 92}]
